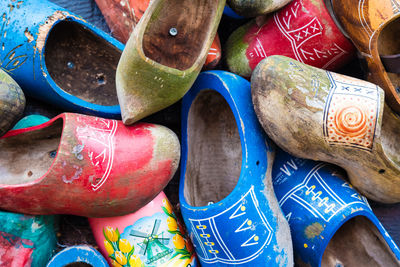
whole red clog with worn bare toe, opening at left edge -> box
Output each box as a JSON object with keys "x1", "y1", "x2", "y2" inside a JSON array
[{"x1": 0, "y1": 113, "x2": 180, "y2": 217}]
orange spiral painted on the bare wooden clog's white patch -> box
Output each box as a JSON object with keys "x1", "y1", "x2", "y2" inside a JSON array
[{"x1": 334, "y1": 106, "x2": 368, "y2": 138}]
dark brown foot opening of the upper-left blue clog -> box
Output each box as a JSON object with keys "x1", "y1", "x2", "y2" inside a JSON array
[{"x1": 45, "y1": 20, "x2": 121, "y2": 106}]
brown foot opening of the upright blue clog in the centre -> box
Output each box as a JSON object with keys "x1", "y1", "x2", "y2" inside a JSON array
[{"x1": 184, "y1": 90, "x2": 242, "y2": 207}]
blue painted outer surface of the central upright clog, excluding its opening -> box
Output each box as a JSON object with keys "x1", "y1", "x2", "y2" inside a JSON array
[{"x1": 179, "y1": 71, "x2": 288, "y2": 266}]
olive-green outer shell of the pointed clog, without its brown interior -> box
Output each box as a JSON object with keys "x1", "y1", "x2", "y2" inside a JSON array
[{"x1": 116, "y1": 0, "x2": 225, "y2": 124}]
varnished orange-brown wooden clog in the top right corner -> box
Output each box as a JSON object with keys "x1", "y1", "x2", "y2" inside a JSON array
[{"x1": 329, "y1": 0, "x2": 400, "y2": 113}]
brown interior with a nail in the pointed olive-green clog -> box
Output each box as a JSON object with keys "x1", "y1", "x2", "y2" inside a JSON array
[{"x1": 142, "y1": 0, "x2": 220, "y2": 70}]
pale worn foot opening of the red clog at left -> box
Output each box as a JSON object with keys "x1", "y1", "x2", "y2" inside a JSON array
[{"x1": 0, "y1": 118, "x2": 63, "y2": 184}]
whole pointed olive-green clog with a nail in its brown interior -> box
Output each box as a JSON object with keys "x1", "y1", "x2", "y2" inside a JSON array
[{"x1": 116, "y1": 0, "x2": 225, "y2": 124}]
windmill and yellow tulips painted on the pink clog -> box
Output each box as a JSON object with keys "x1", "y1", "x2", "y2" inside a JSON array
[{"x1": 103, "y1": 198, "x2": 194, "y2": 267}]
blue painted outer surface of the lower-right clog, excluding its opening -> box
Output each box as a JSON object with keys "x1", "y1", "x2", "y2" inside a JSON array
[{"x1": 272, "y1": 148, "x2": 400, "y2": 266}]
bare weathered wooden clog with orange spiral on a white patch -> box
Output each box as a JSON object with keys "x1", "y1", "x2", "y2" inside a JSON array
[{"x1": 251, "y1": 56, "x2": 400, "y2": 203}]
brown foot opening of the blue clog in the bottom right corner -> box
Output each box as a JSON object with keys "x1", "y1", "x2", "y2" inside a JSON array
[{"x1": 321, "y1": 216, "x2": 399, "y2": 267}]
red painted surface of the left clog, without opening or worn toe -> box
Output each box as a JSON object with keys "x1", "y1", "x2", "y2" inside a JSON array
[{"x1": 0, "y1": 113, "x2": 176, "y2": 217}]
